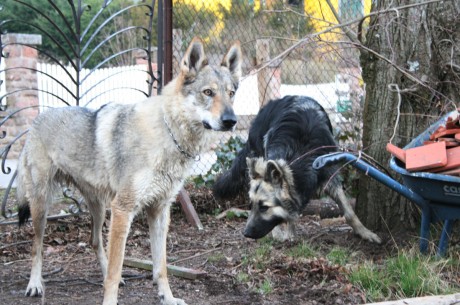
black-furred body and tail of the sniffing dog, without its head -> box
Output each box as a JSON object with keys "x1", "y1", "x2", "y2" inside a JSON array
[{"x1": 213, "y1": 96, "x2": 338, "y2": 206}]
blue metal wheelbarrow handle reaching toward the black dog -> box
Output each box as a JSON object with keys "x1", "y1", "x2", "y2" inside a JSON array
[{"x1": 312, "y1": 152, "x2": 429, "y2": 208}]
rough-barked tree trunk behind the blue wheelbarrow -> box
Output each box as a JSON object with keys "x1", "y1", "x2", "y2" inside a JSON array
[{"x1": 356, "y1": 0, "x2": 460, "y2": 231}]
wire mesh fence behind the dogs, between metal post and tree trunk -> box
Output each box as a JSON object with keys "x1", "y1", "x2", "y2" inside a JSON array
[{"x1": 173, "y1": 0, "x2": 370, "y2": 182}]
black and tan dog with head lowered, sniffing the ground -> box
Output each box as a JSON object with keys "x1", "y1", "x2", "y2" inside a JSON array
[{"x1": 213, "y1": 96, "x2": 381, "y2": 243}]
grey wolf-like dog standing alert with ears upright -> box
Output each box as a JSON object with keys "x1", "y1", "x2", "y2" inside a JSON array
[{"x1": 17, "y1": 38, "x2": 242, "y2": 305}]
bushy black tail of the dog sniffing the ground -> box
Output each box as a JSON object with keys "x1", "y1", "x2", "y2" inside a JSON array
[{"x1": 212, "y1": 144, "x2": 249, "y2": 199}]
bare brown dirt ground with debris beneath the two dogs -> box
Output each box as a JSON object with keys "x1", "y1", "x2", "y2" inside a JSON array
[{"x1": 0, "y1": 188, "x2": 456, "y2": 305}]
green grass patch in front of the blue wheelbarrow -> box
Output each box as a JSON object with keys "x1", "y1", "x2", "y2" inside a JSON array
[{"x1": 349, "y1": 251, "x2": 454, "y2": 302}]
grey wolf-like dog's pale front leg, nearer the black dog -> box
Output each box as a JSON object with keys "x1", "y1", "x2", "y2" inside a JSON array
[{"x1": 146, "y1": 202, "x2": 186, "y2": 305}]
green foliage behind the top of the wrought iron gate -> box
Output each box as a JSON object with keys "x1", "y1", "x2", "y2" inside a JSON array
[{"x1": 0, "y1": 0, "x2": 157, "y2": 68}]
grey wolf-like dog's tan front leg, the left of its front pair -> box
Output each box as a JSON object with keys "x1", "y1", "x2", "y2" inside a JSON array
[{"x1": 103, "y1": 203, "x2": 133, "y2": 305}]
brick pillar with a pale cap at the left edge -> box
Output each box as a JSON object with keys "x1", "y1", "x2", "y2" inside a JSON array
[{"x1": 0, "y1": 34, "x2": 42, "y2": 159}]
